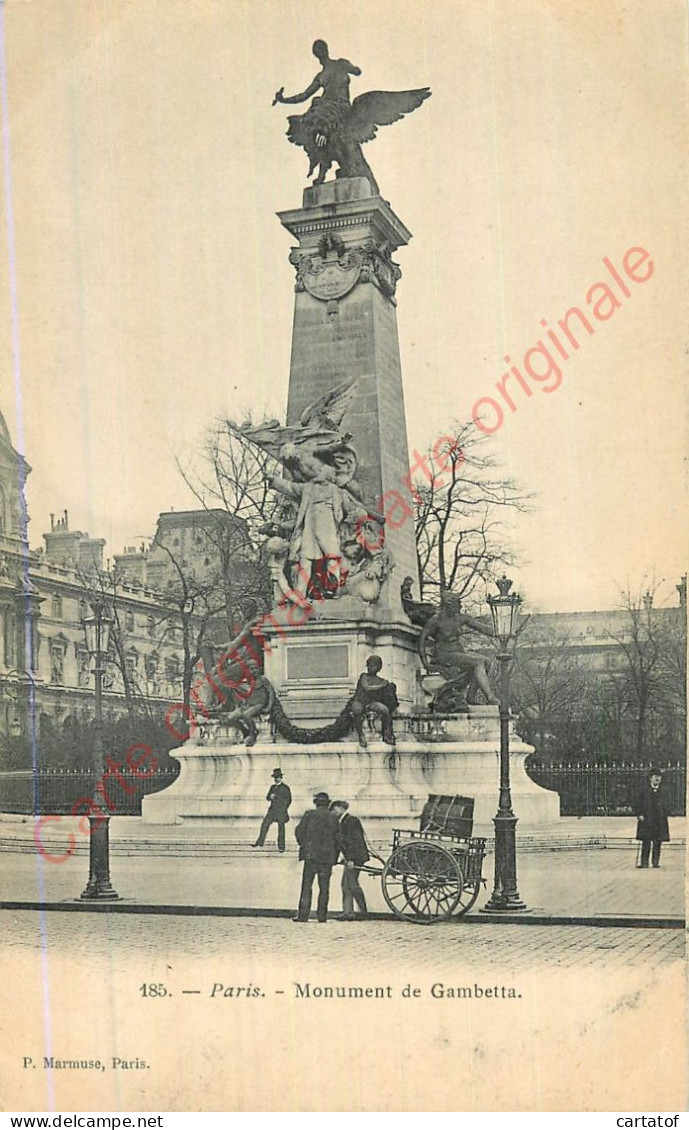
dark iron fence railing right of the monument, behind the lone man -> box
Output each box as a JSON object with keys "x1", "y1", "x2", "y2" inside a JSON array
[{"x1": 526, "y1": 754, "x2": 687, "y2": 816}]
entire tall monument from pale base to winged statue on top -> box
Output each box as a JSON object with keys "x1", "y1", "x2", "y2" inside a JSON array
[{"x1": 143, "y1": 41, "x2": 558, "y2": 838}]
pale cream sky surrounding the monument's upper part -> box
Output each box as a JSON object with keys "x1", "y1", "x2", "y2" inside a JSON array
[{"x1": 0, "y1": 0, "x2": 687, "y2": 610}]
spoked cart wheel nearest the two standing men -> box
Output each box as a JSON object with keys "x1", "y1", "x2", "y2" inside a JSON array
[{"x1": 381, "y1": 840, "x2": 464, "y2": 923}]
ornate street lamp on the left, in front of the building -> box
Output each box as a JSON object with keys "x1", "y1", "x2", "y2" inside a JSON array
[{"x1": 81, "y1": 600, "x2": 120, "y2": 899}]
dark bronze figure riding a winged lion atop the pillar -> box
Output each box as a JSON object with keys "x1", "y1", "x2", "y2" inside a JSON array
[{"x1": 273, "y1": 40, "x2": 430, "y2": 194}]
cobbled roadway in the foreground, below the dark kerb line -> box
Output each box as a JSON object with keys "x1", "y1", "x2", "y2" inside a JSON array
[{"x1": 2, "y1": 911, "x2": 683, "y2": 967}]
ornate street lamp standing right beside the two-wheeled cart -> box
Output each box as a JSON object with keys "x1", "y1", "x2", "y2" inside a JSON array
[{"x1": 483, "y1": 576, "x2": 526, "y2": 912}]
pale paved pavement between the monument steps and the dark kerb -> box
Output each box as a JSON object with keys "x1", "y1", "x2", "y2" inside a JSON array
[{"x1": 0, "y1": 820, "x2": 684, "y2": 929}]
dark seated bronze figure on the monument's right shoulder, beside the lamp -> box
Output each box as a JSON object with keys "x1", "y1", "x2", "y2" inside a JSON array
[{"x1": 419, "y1": 591, "x2": 498, "y2": 712}]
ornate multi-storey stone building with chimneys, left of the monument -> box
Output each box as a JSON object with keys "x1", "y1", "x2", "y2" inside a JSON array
[{"x1": 0, "y1": 415, "x2": 234, "y2": 738}]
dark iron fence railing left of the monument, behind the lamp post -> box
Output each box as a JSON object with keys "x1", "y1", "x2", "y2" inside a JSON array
[{"x1": 0, "y1": 766, "x2": 180, "y2": 816}]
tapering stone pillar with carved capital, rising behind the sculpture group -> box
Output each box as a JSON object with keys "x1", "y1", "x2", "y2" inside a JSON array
[{"x1": 279, "y1": 177, "x2": 418, "y2": 612}]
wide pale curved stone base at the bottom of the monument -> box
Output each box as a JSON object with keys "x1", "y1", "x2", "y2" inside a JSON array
[{"x1": 143, "y1": 707, "x2": 559, "y2": 842}]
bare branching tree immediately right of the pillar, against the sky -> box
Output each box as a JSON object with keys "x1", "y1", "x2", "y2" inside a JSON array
[{"x1": 412, "y1": 424, "x2": 532, "y2": 599}]
